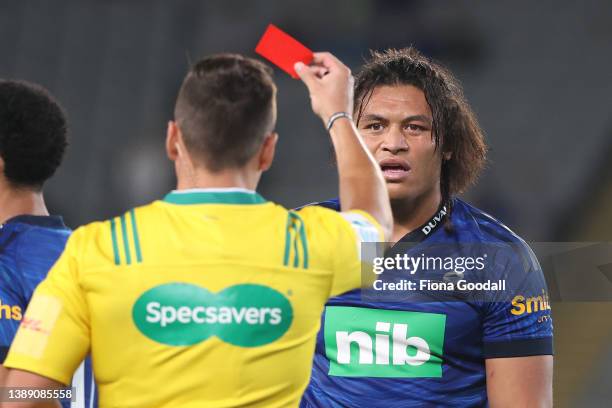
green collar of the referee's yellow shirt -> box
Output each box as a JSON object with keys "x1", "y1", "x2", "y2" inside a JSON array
[{"x1": 164, "y1": 188, "x2": 266, "y2": 205}]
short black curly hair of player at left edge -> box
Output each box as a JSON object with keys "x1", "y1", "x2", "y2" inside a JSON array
[{"x1": 0, "y1": 80, "x2": 68, "y2": 190}]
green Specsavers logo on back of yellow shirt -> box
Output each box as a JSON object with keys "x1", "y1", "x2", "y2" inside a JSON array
[{"x1": 132, "y1": 283, "x2": 293, "y2": 347}]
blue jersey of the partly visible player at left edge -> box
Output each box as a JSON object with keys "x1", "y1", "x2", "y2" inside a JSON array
[{"x1": 0, "y1": 215, "x2": 97, "y2": 407}]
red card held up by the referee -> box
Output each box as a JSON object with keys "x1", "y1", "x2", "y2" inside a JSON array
[{"x1": 255, "y1": 24, "x2": 313, "y2": 79}]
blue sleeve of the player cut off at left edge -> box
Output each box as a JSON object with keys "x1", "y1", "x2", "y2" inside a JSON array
[{"x1": 0, "y1": 262, "x2": 26, "y2": 364}]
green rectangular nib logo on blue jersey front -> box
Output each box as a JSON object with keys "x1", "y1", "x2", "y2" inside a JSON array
[{"x1": 325, "y1": 306, "x2": 446, "y2": 378}]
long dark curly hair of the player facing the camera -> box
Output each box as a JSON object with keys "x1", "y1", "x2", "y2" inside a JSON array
[{"x1": 355, "y1": 47, "x2": 487, "y2": 226}]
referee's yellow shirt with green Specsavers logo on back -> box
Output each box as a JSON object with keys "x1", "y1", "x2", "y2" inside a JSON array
[{"x1": 5, "y1": 189, "x2": 383, "y2": 407}]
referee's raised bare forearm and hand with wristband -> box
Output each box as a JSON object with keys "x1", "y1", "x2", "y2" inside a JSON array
[{"x1": 296, "y1": 52, "x2": 393, "y2": 238}]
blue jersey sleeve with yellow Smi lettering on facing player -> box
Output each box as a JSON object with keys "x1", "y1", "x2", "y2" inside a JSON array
[{"x1": 483, "y1": 243, "x2": 553, "y2": 358}]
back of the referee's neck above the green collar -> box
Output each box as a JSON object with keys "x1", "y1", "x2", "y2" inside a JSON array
[{"x1": 177, "y1": 169, "x2": 259, "y2": 190}]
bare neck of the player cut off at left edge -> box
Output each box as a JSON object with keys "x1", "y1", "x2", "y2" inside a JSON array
[{"x1": 0, "y1": 183, "x2": 49, "y2": 223}]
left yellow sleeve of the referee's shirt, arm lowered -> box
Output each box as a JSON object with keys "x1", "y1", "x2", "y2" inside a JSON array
[{"x1": 5, "y1": 228, "x2": 90, "y2": 385}]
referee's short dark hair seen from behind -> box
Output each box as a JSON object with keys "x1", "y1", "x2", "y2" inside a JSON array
[{"x1": 174, "y1": 54, "x2": 276, "y2": 172}]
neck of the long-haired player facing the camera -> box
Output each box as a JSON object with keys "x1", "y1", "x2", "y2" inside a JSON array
[{"x1": 391, "y1": 188, "x2": 442, "y2": 242}]
